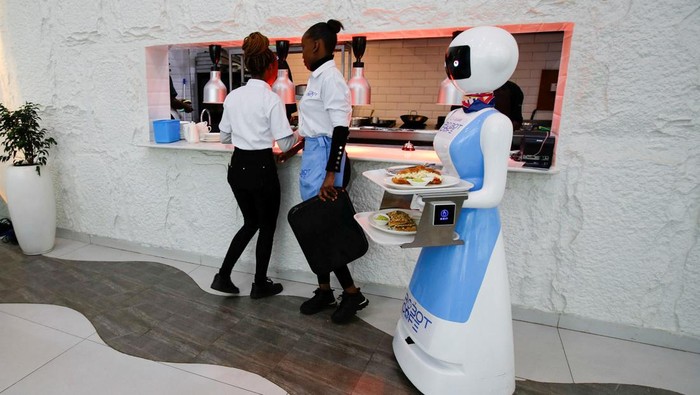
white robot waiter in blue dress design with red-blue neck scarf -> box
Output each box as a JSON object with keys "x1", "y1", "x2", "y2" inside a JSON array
[{"x1": 393, "y1": 26, "x2": 518, "y2": 394}]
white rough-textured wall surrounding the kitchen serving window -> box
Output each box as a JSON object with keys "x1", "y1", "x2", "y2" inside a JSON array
[{"x1": 0, "y1": 0, "x2": 700, "y2": 338}]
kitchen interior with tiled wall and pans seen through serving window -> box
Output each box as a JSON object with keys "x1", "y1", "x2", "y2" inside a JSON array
[{"x1": 168, "y1": 31, "x2": 564, "y2": 170}]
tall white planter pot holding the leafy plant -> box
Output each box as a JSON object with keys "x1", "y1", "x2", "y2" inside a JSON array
[{"x1": 5, "y1": 166, "x2": 56, "y2": 255}]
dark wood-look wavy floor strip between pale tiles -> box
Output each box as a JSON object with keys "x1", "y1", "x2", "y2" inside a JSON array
[{"x1": 0, "y1": 245, "x2": 673, "y2": 395}]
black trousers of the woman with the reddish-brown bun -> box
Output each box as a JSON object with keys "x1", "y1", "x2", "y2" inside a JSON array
[{"x1": 219, "y1": 148, "x2": 280, "y2": 284}]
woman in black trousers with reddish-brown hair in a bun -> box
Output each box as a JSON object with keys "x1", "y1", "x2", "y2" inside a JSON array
[{"x1": 211, "y1": 32, "x2": 297, "y2": 299}]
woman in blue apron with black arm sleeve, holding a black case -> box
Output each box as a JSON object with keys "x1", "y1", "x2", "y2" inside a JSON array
[{"x1": 299, "y1": 19, "x2": 369, "y2": 323}]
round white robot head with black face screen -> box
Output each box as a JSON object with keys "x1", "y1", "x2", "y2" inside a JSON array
[{"x1": 445, "y1": 26, "x2": 518, "y2": 94}]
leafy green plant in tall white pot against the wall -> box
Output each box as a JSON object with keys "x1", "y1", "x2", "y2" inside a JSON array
[{"x1": 0, "y1": 102, "x2": 56, "y2": 255}]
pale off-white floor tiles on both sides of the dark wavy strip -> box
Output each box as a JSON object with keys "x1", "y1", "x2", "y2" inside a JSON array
[{"x1": 0, "y1": 239, "x2": 700, "y2": 395}]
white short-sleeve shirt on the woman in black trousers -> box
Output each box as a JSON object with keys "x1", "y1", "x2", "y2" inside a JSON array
[{"x1": 219, "y1": 79, "x2": 293, "y2": 150}]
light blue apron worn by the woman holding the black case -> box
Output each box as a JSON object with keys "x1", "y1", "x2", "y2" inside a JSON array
[{"x1": 299, "y1": 136, "x2": 345, "y2": 200}]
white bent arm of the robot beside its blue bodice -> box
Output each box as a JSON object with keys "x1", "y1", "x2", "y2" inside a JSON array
[{"x1": 462, "y1": 113, "x2": 513, "y2": 208}]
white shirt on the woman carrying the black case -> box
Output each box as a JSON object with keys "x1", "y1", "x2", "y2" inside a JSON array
[{"x1": 299, "y1": 59, "x2": 352, "y2": 137}]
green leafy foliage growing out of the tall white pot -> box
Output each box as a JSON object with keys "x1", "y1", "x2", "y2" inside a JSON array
[{"x1": 0, "y1": 102, "x2": 57, "y2": 175}]
